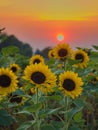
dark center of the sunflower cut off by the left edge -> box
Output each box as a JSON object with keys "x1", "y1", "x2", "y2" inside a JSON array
[{"x1": 0, "y1": 75, "x2": 11, "y2": 88}]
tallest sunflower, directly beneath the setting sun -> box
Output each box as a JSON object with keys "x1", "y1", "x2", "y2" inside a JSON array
[{"x1": 54, "y1": 43, "x2": 72, "y2": 60}]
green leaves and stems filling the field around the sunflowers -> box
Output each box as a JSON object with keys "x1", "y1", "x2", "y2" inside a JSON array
[{"x1": 0, "y1": 36, "x2": 98, "y2": 130}]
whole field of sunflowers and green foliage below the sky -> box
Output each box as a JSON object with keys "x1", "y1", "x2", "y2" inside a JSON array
[{"x1": 0, "y1": 35, "x2": 98, "y2": 130}]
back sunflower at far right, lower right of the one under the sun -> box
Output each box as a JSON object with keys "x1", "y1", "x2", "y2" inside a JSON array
[{"x1": 72, "y1": 50, "x2": 89, "y2": 68}]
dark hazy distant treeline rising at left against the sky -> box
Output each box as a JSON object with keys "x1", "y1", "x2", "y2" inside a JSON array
[{"x1": 0, "y1": 33, "x2": 51, "y2": 59}]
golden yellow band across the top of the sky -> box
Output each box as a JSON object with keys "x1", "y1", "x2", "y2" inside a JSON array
[{"x1": 0, "y1": 0, "x2": 98, "y2": 21}]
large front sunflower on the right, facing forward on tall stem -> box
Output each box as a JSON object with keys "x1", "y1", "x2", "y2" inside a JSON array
[{"x1": 59, "y1": 71, "x2": 83, "y2": 99}]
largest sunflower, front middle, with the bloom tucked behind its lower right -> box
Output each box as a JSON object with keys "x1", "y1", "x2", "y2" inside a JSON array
[{"x1": 23, "y1": 63, "x2": 56, "y2": 93}]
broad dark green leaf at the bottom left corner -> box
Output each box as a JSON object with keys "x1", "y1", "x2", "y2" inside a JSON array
[{"x1": 0, "y1": 109, "x2": 15, "y2": 126}]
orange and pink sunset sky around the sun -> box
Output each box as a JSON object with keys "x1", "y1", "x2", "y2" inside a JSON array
[{"x1": 0, "y1": 0, "x2": 98, "y2": 49}]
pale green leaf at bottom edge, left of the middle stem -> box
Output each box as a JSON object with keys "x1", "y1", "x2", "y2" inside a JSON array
[{"x1": 17, "y1": 121, "x2": 35, "y2": 130}]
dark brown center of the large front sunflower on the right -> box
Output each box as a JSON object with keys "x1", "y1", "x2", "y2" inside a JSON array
[{"x1": 63, "y1": 79, "x2": 75, "y2": 91}]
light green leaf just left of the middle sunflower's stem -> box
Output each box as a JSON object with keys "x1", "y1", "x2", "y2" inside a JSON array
[{"x1": 24, "y1": 103, "x2": 42, "y2": 112}]
